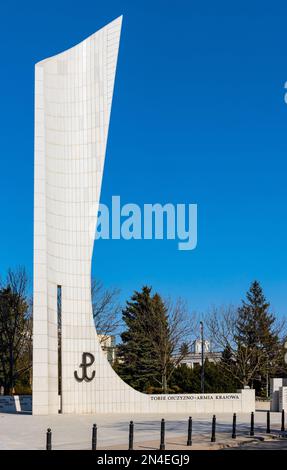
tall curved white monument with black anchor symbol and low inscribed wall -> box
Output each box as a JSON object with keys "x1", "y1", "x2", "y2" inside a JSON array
[{"x1": 33, "y1": 17, "x2": 255, "y2": 415}]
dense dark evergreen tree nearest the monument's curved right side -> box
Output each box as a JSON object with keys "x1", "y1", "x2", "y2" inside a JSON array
[{"x1": 116, "y1": 286, "x2": 171, "y2": 391}]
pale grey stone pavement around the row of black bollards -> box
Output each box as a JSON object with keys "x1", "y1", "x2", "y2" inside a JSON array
[{"x1": 0, "y1": 411, "x2": 287, "y2": 450}]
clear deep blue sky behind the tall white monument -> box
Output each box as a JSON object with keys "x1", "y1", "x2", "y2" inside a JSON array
[{"x1": 0, "y1": 0, "x2": 287, "y2": 315}]
